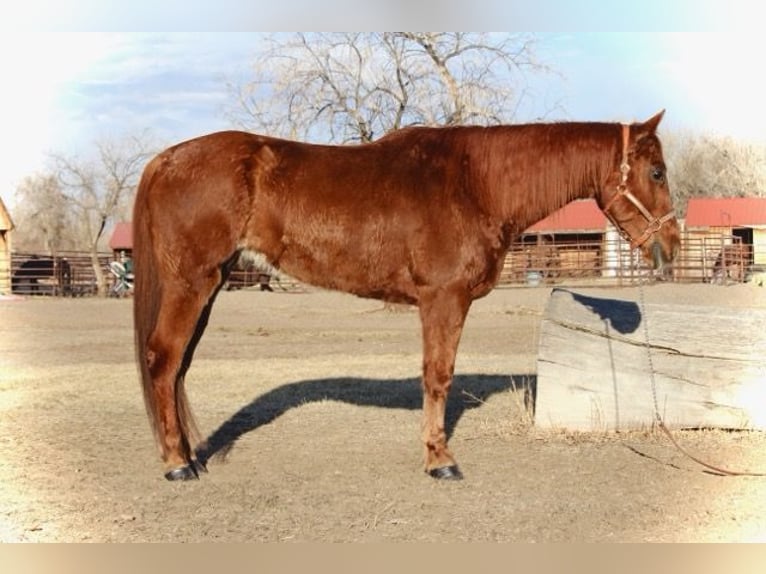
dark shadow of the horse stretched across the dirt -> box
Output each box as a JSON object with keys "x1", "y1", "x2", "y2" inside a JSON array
[{"x1": 196, "y1": 374, "x2": 537, "y2": 464}]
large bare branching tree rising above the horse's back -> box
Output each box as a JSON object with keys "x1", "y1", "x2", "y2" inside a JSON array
[{"x1": 230, "y1": 32, "x2": 549, "y2": 142}]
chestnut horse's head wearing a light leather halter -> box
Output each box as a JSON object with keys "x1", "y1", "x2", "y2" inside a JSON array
[{"x1": 597, "y1": 110, "x2": 681, "y2": 269}]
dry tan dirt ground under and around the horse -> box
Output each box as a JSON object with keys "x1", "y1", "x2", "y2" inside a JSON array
[{"x1": 0, "y1": 284, "x2": 766, "y2": 542}]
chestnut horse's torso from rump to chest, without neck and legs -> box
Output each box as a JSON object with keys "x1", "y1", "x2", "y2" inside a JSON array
[{"x1": 134, "y1": 128, "x2": 504, "y2": 302}]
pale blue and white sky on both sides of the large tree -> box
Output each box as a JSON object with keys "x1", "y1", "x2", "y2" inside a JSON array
[{"x1": 0, "y1": 0, "x2": 766, "y2": 212}]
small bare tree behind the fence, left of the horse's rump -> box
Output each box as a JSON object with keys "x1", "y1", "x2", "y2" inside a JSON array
[{"x1": 53, "y1": 135, "x2": 151, "y2": 294}]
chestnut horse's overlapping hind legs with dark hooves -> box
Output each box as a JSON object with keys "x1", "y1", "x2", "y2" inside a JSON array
[{"x1": 146, "y1": 269, "x2": 221, "y2": 480}]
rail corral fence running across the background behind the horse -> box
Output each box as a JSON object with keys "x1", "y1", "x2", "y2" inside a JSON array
[{"x1": 11, "y1": 235, "x2": 753, "y2": 296}]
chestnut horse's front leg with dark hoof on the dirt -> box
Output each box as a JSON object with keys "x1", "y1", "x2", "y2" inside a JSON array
[{"x1": 420, "y1": 288, "x2": 471, "y2": 479}]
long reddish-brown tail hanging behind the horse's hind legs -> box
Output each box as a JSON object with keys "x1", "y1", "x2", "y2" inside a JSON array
[{"x1": 133, "y1": 159, "x2": 170, "y2": 450}]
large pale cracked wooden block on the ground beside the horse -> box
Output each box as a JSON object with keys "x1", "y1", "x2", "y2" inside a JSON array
[{"x1": 534, "y1": 289, "x2": 766, "y2": 431}]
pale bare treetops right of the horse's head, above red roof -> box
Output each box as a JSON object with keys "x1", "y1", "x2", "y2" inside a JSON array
[{"x1": 663, "y1": 132, "x2": 766, "y2": 215}]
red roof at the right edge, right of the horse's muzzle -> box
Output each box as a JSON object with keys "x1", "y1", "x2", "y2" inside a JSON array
[{"x1": 686, "y1": 197, "x2": 766, "y2": 227}]
